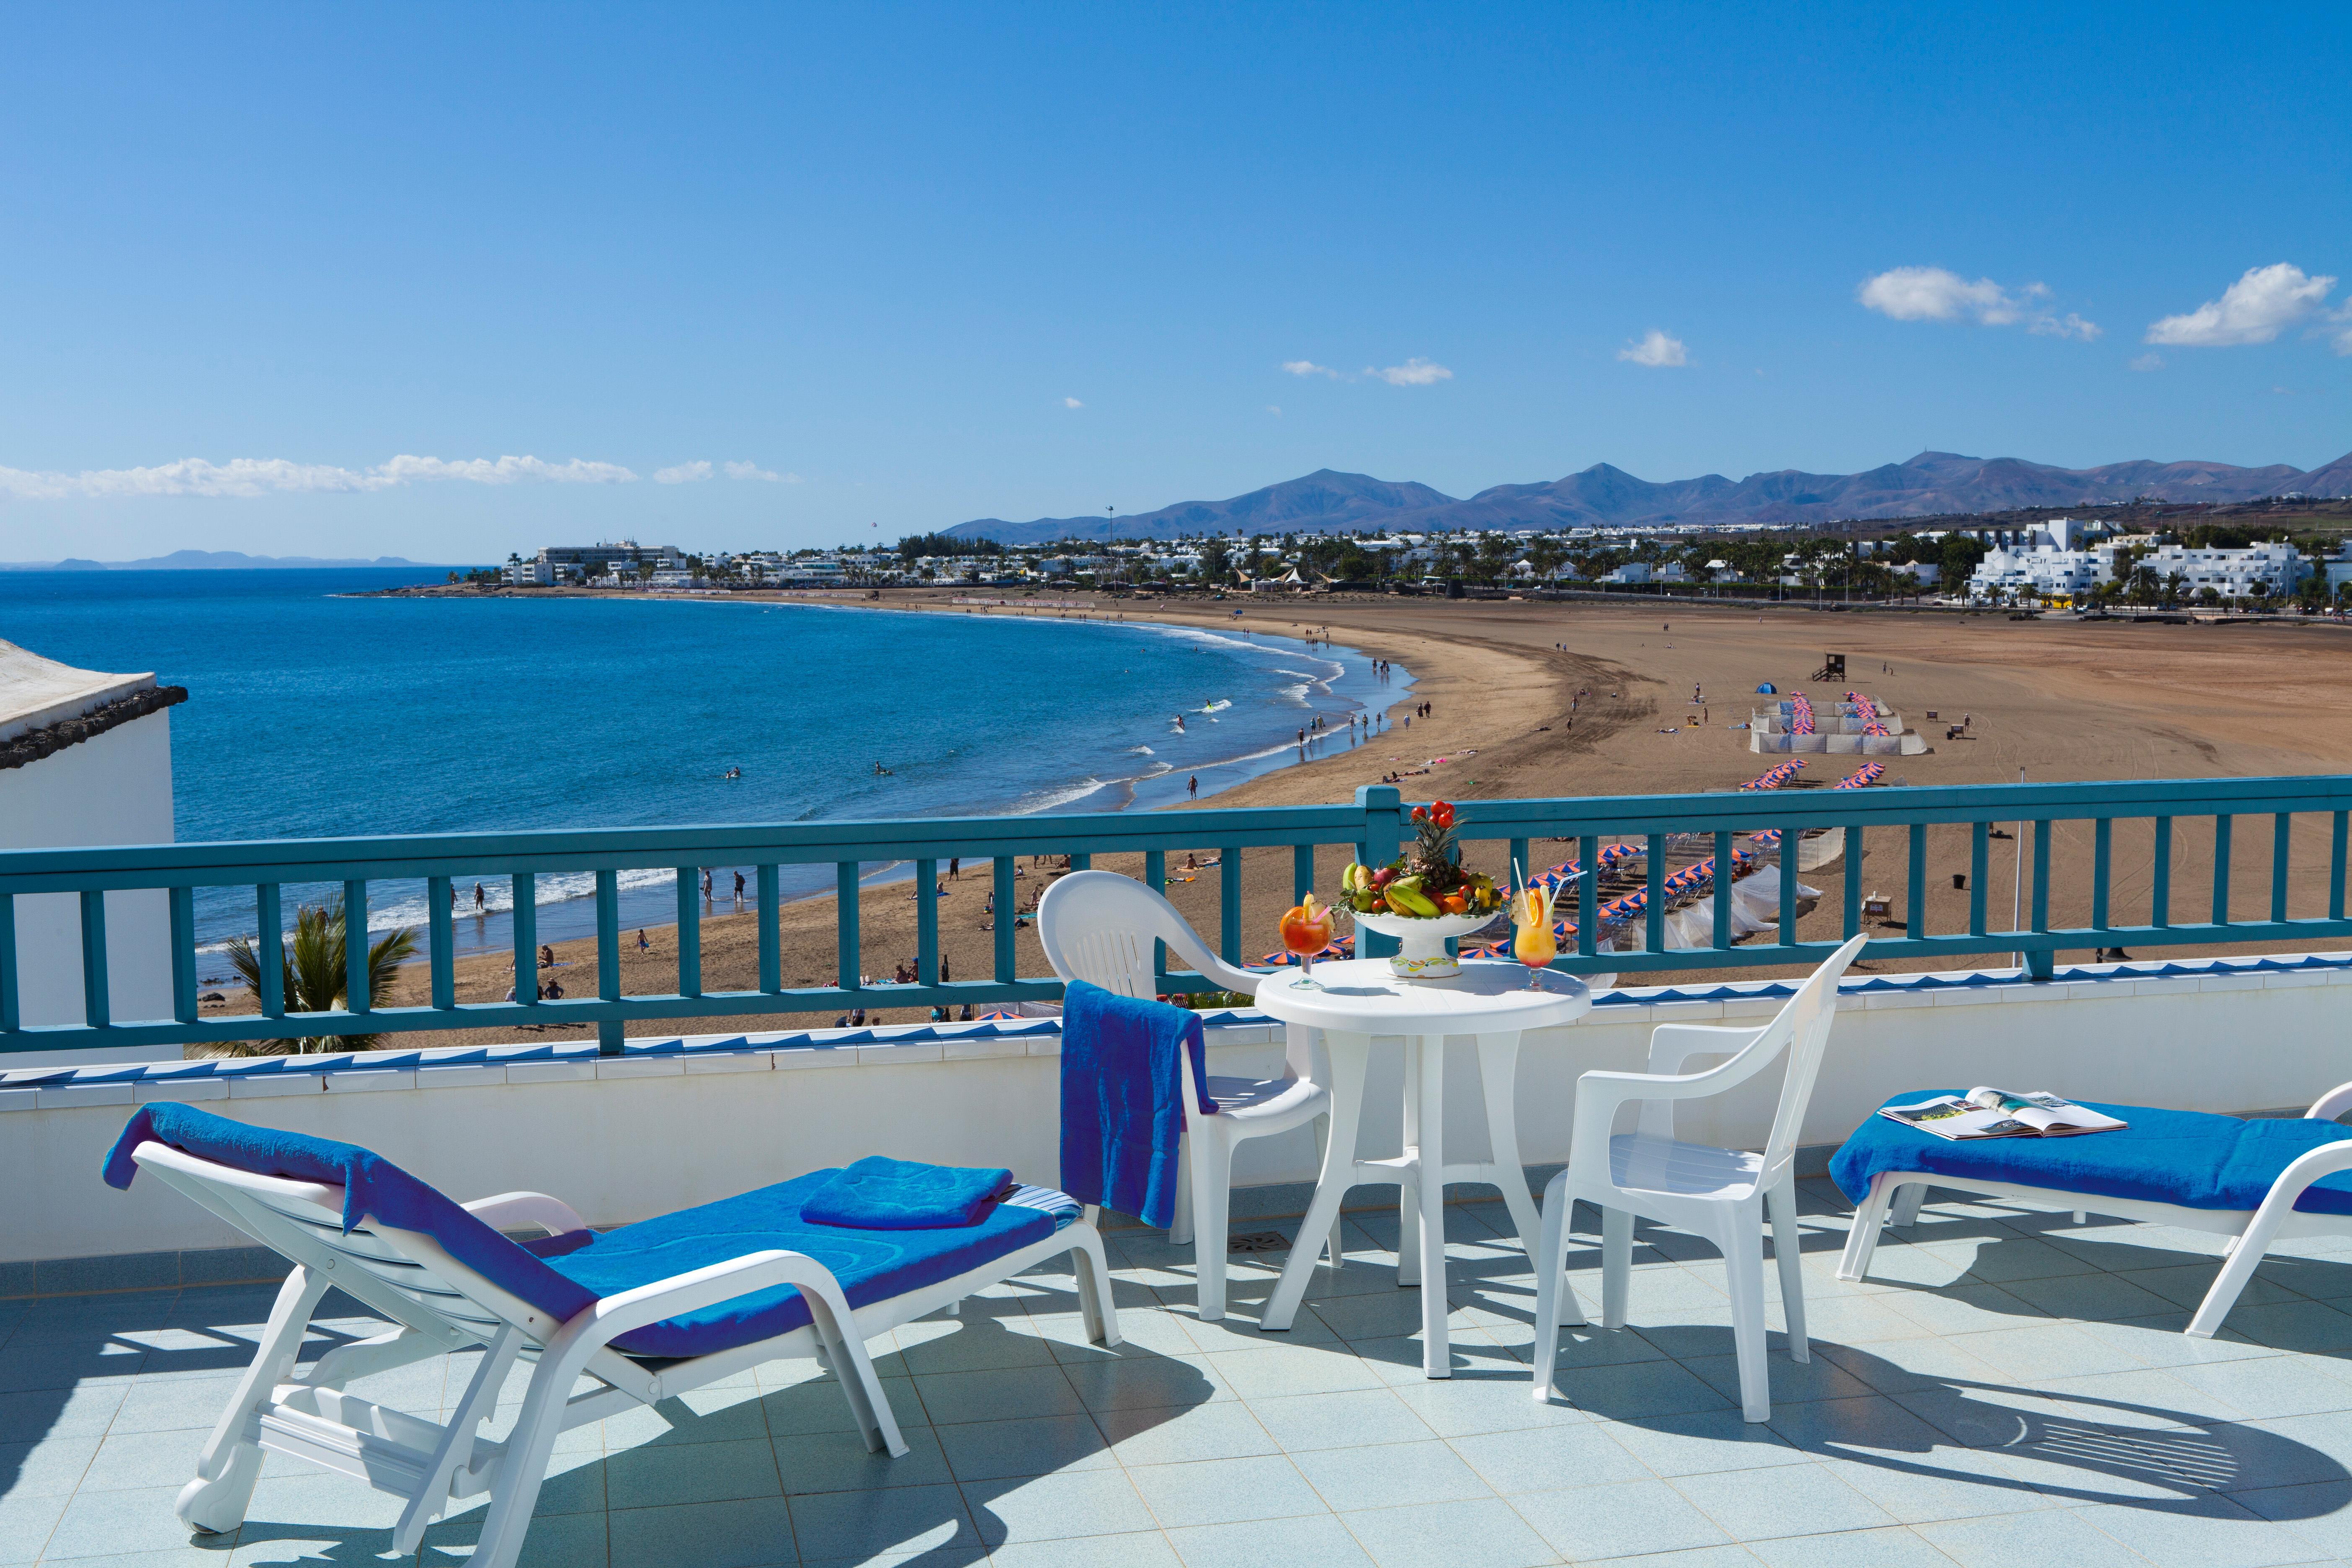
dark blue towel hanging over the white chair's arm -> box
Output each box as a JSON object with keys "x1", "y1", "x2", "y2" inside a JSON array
[{"x1": 1061, "y1": 980, "x2": 1216, "y2": 1230}]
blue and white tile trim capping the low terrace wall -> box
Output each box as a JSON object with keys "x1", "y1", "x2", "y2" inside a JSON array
[{"x1": 0, "y1": 952, "x2": 2352, "y2": 1112}]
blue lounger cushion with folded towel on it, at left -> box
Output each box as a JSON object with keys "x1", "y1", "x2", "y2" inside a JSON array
[{"x1": 106, "y1": 1103, "x2": 1077, "y2": 1357}]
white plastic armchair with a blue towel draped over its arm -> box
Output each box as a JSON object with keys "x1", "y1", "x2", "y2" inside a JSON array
[{"x1": 1037, "y1": 872, "x2": 1341, "y2": 1323}]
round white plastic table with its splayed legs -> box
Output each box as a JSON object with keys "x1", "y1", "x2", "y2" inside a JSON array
[{"x1": 1259, "y1": 959, "x2": 1592, "y2": 1377}]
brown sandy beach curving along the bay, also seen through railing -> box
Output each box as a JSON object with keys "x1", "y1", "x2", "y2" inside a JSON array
[{"x1": 205, "y1": 593, "x2": 2352, "y2": 1044}]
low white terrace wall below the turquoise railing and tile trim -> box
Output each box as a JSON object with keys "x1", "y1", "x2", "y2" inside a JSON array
[{"x1": 13, "y1": 954, "x2": 2352, "y2": 1265}]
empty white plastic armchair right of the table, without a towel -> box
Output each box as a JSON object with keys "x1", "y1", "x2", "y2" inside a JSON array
[{"x1": 1536, "y1": 936, "x2": 1870, "y2": 1422}]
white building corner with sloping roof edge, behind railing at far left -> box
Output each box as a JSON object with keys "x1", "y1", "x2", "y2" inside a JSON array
[{"x1": 0, "y1": 642, "x2": 188, "y2": 1067}]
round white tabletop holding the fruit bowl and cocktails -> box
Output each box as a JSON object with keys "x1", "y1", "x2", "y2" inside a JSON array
[{"x1": 1259, "y1": 959, "x2": 1592, "y2": 1034}]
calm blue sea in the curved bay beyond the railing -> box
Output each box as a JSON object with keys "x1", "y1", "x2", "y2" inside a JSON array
[{"x1": 0, "y1": 569, "x2": 1409, "y2": 947}]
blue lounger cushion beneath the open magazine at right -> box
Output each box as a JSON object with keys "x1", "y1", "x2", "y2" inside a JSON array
[{"x1": 1830, "y1": 1088, "x2": 2352, "y2": 1213}]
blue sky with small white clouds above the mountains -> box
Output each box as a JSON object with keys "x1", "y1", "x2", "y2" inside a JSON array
[{"x1": 0, "y1": 5, "x2": 2352, "y2": 560}]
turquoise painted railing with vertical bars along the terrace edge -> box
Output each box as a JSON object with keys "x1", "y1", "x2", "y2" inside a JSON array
[{"x1": 0, "y1": 776, "x2": 2352, "y2": 1051}]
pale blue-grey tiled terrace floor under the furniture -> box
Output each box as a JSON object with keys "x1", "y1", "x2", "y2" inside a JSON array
[{"x1": 0, "y1": 1182, "x2": 2352, "y2": 1568}]
